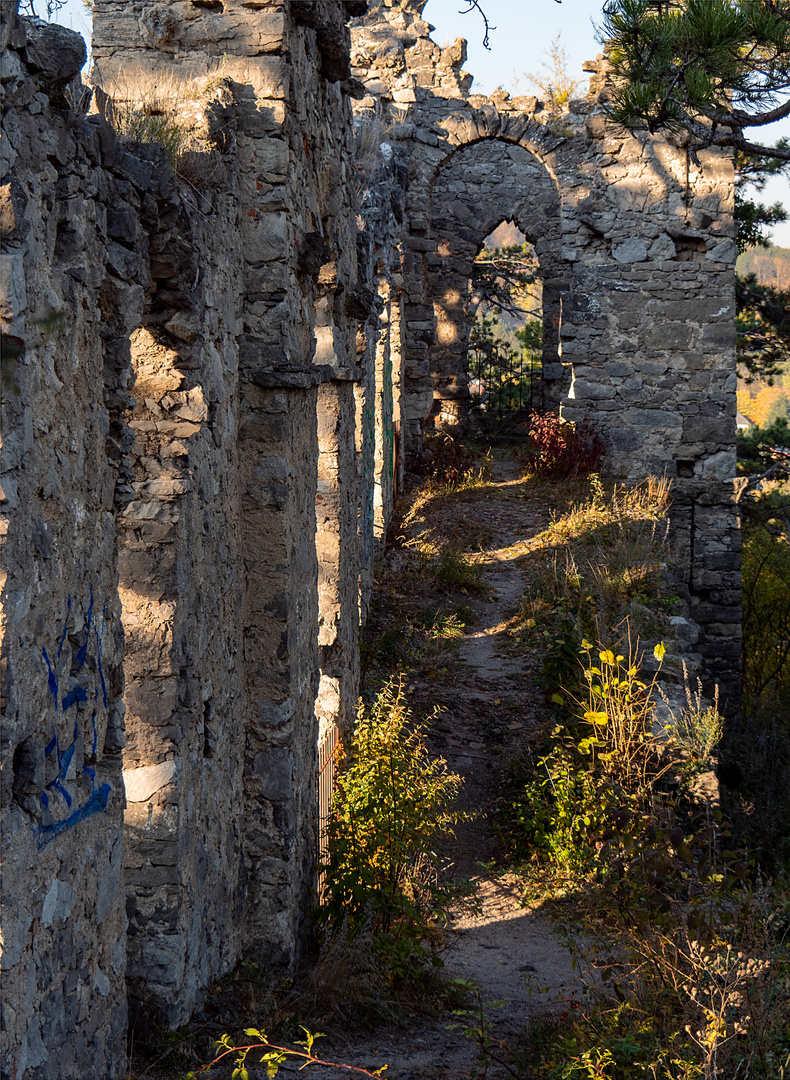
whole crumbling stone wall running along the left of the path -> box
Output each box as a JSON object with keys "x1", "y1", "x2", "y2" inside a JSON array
[{"x1": 2, "y1": 3, "x2": 397, "y2": 1077}]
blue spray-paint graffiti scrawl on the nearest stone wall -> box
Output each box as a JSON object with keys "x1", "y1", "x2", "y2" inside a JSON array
[{"x1": 38, "y1": 589, "x2": 112, "y2": 849}]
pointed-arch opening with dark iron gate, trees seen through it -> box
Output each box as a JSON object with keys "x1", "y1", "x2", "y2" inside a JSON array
[{"x1": 467, "y1": 221, "x2": 544, "y2": 421}]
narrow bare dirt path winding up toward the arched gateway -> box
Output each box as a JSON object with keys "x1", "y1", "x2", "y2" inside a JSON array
[{"x1": 313, "y1": 451, "x2": 579, "y2": 1080}]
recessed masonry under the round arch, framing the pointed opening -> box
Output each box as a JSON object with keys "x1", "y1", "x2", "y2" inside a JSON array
[{"x1": 426, "y1": 137, "x2": 570, "y2": 422}]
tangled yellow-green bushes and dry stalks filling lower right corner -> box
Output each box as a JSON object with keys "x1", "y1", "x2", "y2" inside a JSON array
[{"x1": 511, "y1": 642, "x2": 790, "y2": 1080}]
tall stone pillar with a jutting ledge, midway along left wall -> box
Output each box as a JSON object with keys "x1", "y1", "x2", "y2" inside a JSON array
[{"x1": 226, "y1": 0, "x2": 365, "y2": 964}]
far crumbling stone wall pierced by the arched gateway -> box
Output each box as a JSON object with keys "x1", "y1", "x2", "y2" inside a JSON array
[{"x1": 352, "y1": 0, "x2": 740, "y2": 707}]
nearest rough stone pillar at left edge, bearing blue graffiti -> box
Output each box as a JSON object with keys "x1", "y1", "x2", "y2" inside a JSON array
[{"x1": 0, "y1": 12, "x2": 128, "y2": 1080}]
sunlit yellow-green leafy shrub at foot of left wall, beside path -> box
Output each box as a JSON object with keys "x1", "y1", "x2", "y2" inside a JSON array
[{"x1": 319, "y1": 676, "x2": 461, "y2": 981}]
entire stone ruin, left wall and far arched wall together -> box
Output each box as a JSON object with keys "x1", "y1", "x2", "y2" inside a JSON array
[{"x1": 0, "y1": 0, "x2": 739, "y2": 1080}]
